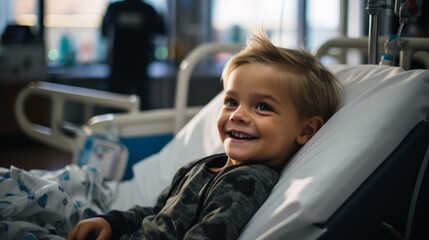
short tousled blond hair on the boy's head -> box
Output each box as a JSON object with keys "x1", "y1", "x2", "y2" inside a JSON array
[{"x1": 222, "y1": 30, "x2": 341, "y2": 122}]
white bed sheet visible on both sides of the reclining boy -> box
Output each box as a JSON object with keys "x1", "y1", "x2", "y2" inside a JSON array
[{"x1": 111, "y1": 65, "x2": 429, "y2": 239}]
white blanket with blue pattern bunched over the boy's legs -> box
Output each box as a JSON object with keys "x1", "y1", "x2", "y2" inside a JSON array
[{"x1": 0, "y1": 165, "x2": 114, "y2": 239}]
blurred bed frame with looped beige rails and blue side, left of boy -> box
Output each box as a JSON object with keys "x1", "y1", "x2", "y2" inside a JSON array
[{"x1": 15, "y1": 43, "x2": 242, "y2": 180}]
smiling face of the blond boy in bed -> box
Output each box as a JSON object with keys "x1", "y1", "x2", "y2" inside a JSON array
[{"x1": 218, "y1": 63, "x2": 306, "y2": 169}]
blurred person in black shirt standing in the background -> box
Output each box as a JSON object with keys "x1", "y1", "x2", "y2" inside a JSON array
[{"x1": 101, "y1": 0, "x2": 165, "y2": 110}]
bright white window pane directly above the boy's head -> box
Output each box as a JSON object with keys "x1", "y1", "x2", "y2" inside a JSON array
[{"x1": 212, "y1": 0, "x2": 298, "y2": 47}]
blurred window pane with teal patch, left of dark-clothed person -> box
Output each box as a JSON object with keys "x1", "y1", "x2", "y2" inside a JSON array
[{"x1": 44, "y1": 0, "x2": 106, "y2": 65}]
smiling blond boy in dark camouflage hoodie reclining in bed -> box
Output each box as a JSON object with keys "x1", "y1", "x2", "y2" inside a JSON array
[{"x1": 67, "y1": 32, "x2": 340, "y2": 239}]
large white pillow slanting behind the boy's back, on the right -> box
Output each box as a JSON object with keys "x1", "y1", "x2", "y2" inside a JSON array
[{"x1": 240, "y1": 65, "x2": 429, "y2": 239}]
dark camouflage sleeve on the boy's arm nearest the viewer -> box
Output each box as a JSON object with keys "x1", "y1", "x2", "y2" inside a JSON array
[{"x1": 184, "y1": 164, "x2": 279, "y2": 239}]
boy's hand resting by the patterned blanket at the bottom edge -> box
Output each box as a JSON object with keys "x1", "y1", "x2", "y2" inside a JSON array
[{"x1": 67, "y1": 217, "x2": 112, "y2": 240}]
